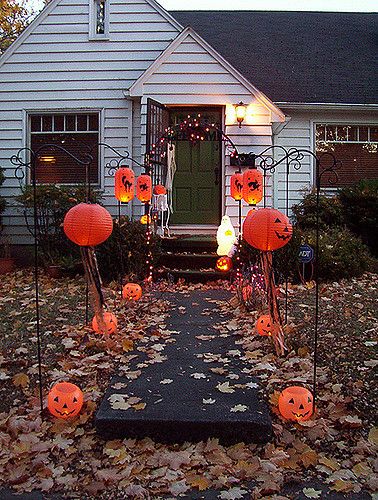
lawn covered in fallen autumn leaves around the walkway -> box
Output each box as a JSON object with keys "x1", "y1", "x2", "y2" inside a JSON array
[{"x1": 0, "y1": 271, "x2": 378, "y2": 499}]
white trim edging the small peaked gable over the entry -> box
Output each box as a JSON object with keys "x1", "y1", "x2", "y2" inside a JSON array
[{"x1": 128, "y1": 26, "x2": 285, "y2": 122}]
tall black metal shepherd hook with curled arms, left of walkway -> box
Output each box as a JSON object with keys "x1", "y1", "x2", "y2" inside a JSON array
[{"x1": 10, "y1": 144, "x2": 92, "y2": 416}]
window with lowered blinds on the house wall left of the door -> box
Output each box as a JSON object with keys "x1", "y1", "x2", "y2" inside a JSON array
[{"x1": 30, "y1": 113, "x2": 99, "y2": 184}]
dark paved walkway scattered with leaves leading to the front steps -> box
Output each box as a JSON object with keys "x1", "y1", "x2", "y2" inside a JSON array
[{"x1": 96, "y1": 290, "x2": 271, "y2": 444}]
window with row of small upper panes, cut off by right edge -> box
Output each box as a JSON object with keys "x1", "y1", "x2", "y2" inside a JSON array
[{"x1": 315, "y1": 124, "x2": 378, "y2": 187}]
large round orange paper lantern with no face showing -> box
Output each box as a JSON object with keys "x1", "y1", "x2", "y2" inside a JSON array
[{"x1": 63, "y1": 203, "x2": 113, "y2": 247}]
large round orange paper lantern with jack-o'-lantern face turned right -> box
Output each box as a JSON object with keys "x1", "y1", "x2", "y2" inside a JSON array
[{"x1": 243, "y1": 208, "x2": 293, "y2": 252}]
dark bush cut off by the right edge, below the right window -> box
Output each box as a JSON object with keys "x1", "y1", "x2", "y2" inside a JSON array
[{"x1": 338, "y1": 180, "x2": 378, "y2": 256}]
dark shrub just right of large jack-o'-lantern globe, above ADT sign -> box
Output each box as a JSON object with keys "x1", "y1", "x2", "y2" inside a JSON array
[{"x1": 292, "y1": 191, "x2": 344, "y2": 229}]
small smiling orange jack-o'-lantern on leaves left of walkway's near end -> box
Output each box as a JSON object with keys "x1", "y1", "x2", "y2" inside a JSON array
[{"x1": 47, "y1": 382, "x2": 83, "y2": 419}]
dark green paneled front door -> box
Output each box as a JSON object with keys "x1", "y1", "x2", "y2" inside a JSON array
[{"x1": 170, "y1": 112, "x2": 222, "y2": 224}]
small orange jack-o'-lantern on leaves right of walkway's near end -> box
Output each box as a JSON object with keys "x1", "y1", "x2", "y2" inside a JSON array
[{"x1": 278, "y1": 385, "x2": 314, "y2": 422}]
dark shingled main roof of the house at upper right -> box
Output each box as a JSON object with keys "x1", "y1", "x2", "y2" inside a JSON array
[{"x1": 171, "y1": 11, "x2": 378, "y2": 104}]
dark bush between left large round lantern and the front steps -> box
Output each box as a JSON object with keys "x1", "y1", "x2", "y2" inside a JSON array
[{"x1": 96, "y1": 217, "x2": 160, "y2": 281}]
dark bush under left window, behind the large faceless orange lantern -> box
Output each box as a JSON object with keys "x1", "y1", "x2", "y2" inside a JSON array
[{"x1": 16, "y1": 184, "x2": 101, "y2": 264}]
